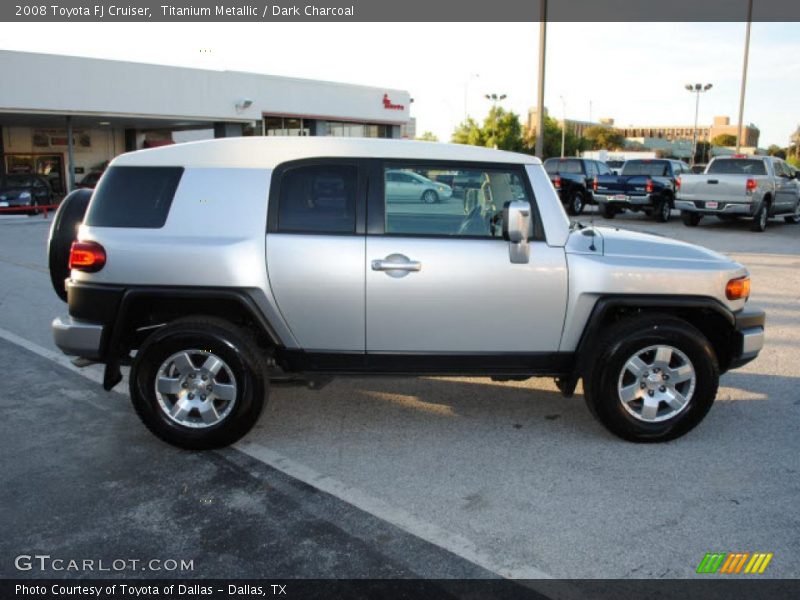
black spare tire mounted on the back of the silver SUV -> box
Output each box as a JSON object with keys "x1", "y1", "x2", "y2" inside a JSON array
[{"x1": 47, "y1": 190, "x2": 92, "y2": 302}]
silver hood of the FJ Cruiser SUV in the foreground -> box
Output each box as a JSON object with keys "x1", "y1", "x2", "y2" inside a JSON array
[{"x1": 567, "y1": 227, "x2": 732, "y2": 263}]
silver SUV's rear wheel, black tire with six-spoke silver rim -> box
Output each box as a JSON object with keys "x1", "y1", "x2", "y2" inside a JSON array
[{"x1": 130, "y1": 317, "x2": 267, "y2": 450}]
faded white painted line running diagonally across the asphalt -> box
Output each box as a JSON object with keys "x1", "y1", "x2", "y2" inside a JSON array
[{"x1": 0, "y1": 328, "x2": 582, "y2": 599}]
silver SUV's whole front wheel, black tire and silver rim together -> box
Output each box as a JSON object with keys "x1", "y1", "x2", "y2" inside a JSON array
[{"x1": 584, "y1": 314, "x2": 719, "y2": 442}]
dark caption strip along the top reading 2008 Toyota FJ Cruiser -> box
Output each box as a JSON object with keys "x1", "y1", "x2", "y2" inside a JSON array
[{"x1": 0, "y1": 0, "x2": 800, "y2": 22}]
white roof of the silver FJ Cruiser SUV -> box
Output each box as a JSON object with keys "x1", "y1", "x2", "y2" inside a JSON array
[{"x1": 111, "y1": 136, "x2": 541, "y2": 169}]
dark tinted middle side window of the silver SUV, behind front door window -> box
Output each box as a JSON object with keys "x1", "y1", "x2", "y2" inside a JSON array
[{"x1": 278, "y1": 165, "x2": 358, "y2": 233}]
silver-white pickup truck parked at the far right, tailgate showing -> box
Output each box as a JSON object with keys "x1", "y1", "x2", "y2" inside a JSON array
[{"x1": 675, "y1": 155, "x2": 800, "y2": 231}]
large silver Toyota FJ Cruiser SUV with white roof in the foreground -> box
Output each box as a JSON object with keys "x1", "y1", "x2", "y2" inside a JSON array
[{"x1": 50, "y1": 138, "x2": 764, "y2": 449}]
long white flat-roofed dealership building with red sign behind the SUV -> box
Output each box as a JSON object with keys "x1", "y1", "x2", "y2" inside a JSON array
[{"x1": 0, "y1": 50, "x2": 414, "y2": 195}]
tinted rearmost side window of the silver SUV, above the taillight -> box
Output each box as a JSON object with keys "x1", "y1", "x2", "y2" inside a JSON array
[{"x1": 85, "y1": 167, "x2": 183, "y2": 229}]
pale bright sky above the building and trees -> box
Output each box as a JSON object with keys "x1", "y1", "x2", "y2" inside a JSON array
[{"x1": 0, "y1": 23, "x2": 800, "y2": 147}]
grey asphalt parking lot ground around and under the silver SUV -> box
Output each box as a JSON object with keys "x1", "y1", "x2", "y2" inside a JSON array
[{"x1": 0, "y1": 213, "x2": 800, "y2": 579}]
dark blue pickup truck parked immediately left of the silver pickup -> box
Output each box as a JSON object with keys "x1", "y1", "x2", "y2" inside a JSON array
[{"x1": 593, "y1": 158, "x2": 691, "y2": 223}]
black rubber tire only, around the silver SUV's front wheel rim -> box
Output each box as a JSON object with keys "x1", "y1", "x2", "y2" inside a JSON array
[{"x1": 583, "y1": 314, "x2": 719, "y2": 443}]
